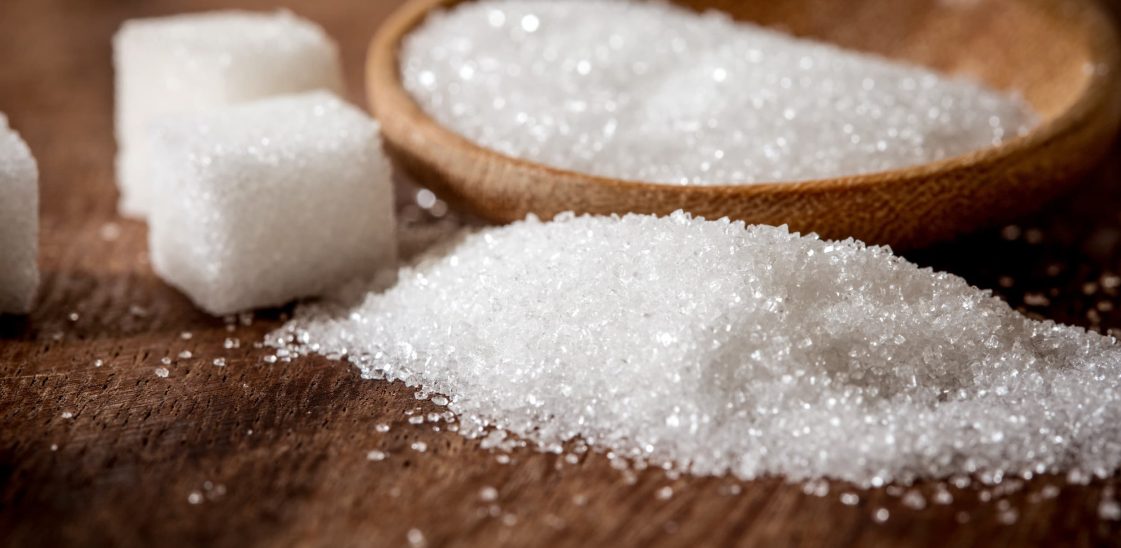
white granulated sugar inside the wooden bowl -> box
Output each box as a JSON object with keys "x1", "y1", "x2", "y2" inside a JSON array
[{"x1": 401, "y1": 0, "x2": 1036, "y2": 184}]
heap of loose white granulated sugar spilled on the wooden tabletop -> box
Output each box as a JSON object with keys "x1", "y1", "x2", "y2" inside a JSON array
[{"x1": 269, "y1": 213, "x2": 1121, "y2": 486}]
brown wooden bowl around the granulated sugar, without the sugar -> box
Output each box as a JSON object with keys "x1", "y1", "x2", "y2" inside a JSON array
[{"x1": 367, "y1": 0, "x2": 1121, "y2": 248}]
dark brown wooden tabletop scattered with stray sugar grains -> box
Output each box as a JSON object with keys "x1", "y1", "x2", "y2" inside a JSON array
[{"x1": 0, "y1": 0, "x2": 1121, "y2": 546}]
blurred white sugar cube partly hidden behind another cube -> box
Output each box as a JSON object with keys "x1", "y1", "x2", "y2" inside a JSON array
[{"x1": 113, "y1": 11, "x2": 343, "y2": 217}]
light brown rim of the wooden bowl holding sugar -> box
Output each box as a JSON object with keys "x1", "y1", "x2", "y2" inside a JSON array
[{"x1": 365, "y1": 0, "x2": 1121, "y2": 197}]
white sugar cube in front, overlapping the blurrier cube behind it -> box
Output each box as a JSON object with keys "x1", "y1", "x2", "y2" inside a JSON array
[{"x1": 149, "y1": 92, "x2": 396, "y2": 315}]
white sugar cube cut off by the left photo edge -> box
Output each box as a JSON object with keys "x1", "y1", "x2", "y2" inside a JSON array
[{"x1": 0, "y1": 113, "x2": 39, "y2": 314}]
